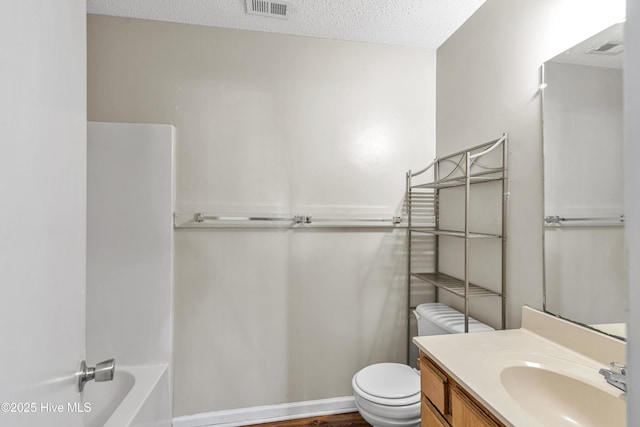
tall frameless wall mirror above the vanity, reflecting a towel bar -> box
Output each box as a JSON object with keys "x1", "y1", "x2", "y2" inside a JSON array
[{"x1": 541, "y1": 23, "x2": 627, "y2": 338}]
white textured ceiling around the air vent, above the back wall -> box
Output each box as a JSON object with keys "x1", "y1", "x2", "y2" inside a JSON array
[{"x1": 87, "y1": 0, "x2": 485, "y2": 49}]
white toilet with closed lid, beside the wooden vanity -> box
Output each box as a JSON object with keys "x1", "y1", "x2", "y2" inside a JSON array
[{"x1": 351, "y1": 303, "x2": 494, "y2": 427}]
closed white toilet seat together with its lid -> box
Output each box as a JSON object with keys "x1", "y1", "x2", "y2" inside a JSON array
[{"x1": 351, "y1": 363, "x2": 420, "y2": 406}]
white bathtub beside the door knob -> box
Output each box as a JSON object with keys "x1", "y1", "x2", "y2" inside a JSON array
[{"x1": 82, "y1": 363, "x2": 171, "y2": 427}]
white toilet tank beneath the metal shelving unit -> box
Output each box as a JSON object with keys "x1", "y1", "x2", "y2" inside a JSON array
[{"x1": 413, "y1": 302, "x2": 495, "y2": 336}]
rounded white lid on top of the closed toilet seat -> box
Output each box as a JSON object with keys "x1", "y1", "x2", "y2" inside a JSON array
[{"x1": 355, "y1": 363, "x2": 420, "y2": 399}]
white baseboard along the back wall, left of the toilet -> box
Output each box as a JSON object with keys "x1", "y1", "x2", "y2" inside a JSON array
[{"x1": 173, "y1": 396, "x2": 358, "y2": 427}]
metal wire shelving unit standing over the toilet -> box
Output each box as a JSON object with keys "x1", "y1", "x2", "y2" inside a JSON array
[{"x1": 406, "y1": 134, "x2": 509, "y2": 362}]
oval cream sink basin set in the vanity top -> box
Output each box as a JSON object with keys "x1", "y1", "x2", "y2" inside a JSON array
[{"x1": 500, "y1": 365, "x2": 626, "y2": 427}]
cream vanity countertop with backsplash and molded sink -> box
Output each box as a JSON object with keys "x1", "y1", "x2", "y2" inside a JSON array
[{"x1": 413, "y1": 307, "x2": 626, "y2": 427}]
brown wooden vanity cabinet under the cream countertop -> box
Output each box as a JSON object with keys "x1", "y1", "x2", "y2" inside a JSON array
[{"x1": 420, "y1": 352, "x2": 505, "y2": 427}]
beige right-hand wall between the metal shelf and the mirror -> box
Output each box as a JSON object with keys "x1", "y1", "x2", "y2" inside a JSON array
[{"x1": 436, "y1": 0, "x2": 624, "y2": 328}]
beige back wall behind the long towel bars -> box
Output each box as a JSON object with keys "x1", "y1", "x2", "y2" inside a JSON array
[{"x1": 88, "y1": 16, "x2": 435, "y2": 416}]
